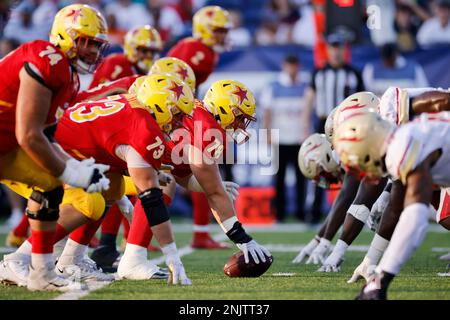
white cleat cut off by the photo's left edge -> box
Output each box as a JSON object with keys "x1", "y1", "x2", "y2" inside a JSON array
[{"x1": 0, "y1": 253, "x2": 31, "y2": 287}]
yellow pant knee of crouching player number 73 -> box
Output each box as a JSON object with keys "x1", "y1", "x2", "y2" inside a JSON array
[{"x1": 62, "y1": 188, "x2": 105, "y2": 221}]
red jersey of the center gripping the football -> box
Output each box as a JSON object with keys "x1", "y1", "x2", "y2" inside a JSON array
[{"x1": 163, "y1": 100, "x2": 227, "y2": 177}]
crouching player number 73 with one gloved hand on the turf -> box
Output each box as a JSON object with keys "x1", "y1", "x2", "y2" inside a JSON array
[{"x1": 0, "y1": 74, "x2": 194, "y2": 284}]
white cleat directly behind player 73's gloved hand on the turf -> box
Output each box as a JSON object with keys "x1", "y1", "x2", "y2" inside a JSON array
[{"x1": 117, "y1": 258, "x2": 169, "y2": 280}]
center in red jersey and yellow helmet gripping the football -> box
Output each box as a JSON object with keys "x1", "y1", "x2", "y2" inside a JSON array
[{"x1": 117, "y1": 80, "x2": 270, "y2": 280}]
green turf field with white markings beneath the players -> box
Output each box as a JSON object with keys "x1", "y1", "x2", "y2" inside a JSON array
[{"x1": 0, "y1": 224, "x2": 450, "y2": 300}]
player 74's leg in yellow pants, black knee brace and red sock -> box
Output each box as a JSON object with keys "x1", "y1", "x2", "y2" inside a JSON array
[{"x1": 0, "y1": 148, "x2": 80, "y2": 291}]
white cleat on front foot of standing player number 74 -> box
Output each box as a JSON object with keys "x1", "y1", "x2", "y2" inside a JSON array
[{"x1": 27, "y1": 264, "x2": 87, "y2": 292}]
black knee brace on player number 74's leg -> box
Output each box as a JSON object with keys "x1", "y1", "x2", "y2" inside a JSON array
[{"x1": 26, "y1": 186, "x2": 64, "y2": 221}]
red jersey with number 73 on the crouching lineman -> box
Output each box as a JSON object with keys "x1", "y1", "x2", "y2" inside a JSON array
[{"x1": 55, "y1": 95, "x2": 165, "y2": 172}]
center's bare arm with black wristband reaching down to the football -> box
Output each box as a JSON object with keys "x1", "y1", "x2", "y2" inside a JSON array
[{"x1": 189, "y1": 146, "x2": 271, "y2": 263}]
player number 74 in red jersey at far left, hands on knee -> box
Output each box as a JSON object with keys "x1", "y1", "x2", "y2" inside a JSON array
[{"x1": 0, "y1": 5, "x2": 109, "y2": 290}]
